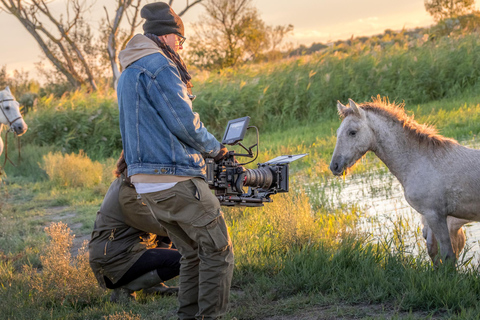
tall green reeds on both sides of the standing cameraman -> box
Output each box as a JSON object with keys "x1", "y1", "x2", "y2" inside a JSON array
[{"x1": 14, "y1": 34, "x2": 480, "y2": 159}]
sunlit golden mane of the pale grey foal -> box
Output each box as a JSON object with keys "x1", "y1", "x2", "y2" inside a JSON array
[{"x1": 340, "y1": 96, "x2": 458, "y2": 148}]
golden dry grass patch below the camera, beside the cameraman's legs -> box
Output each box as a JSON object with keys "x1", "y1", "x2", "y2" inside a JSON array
[{"x1": 225, "y1": 191, "x2": 354, "y2": 260}]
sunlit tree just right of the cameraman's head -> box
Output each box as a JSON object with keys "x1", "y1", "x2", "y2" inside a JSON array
[{"x1": 188, "y1": 0, "x2": 293, "y2": 69}]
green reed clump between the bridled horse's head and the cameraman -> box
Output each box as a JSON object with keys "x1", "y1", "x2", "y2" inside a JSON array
[{"x1": 22, "y1": 91, "x2": 122, "y2": 159}]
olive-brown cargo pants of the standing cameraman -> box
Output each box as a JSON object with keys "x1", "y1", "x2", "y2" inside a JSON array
[{"x1": 141, "y1": 178, "x2": 234, "y2": 320}]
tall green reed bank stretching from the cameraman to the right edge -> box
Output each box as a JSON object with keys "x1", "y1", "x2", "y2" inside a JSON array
[{"x1": 195, "y1": 34, "x2": 480, "y2": 131}]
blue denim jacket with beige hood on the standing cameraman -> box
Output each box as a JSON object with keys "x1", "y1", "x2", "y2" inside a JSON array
[{"x1": 117, "y1": 35, "x2": 221, "y2": 178}]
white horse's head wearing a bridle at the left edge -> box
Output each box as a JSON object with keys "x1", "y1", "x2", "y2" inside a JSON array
[{"x1": 0, "y1": 87, "x2": 28, "y2": 155}]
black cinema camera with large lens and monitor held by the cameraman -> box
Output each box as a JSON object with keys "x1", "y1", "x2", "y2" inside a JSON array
[{"x1": 206, "y1": 117, "x2": 307, "y2": 207}]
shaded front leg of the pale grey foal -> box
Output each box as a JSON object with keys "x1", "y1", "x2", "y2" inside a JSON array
[{"x1": 423, "y1": 211, "x2": 456, "y2": 265}]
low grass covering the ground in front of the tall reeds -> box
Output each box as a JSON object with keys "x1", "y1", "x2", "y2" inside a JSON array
[{"x1": 0, "y1": 91, "x2": 480, "y2": 319}]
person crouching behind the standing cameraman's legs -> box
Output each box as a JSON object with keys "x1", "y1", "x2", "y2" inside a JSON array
[{"x1": 89, "y1": 152, "x2": 181, "y2": 302}]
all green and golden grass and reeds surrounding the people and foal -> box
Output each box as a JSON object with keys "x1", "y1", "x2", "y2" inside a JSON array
[{"x1": 0, "y1": 26, "x2": 480, "y2": 320}]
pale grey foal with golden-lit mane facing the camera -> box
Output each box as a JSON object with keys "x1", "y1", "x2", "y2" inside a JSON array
[{"x1": 330, "y1": 99, "x2": 480, "y2": 264}]
